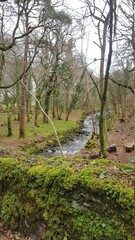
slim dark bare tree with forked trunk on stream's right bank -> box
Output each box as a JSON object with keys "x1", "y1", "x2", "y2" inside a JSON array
[{"x1": 85, "y1": 0, "x2": 116, "y2": 157}]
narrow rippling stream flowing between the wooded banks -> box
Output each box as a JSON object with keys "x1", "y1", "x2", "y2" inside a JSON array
[{"x1": 42, "y1": 113, "x2": 99, "y2": 157}]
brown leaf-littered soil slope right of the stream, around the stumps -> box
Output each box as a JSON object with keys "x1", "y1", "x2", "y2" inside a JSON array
[{"x1": 79, "y1": 118, "x2": 135, "y2": 164}]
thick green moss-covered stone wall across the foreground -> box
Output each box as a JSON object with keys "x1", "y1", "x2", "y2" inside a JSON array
[{"x1": 0, "y1": 157, "x2": 135, "y2": 240}]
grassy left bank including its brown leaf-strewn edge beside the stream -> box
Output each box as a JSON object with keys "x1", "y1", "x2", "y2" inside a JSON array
[{"x1": 0, "y1": 111, "x2": 84, "y2": 158}]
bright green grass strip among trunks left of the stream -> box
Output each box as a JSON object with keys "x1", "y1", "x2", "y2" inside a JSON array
[{"x1": 0, "y1": 112, "x2": 81, "y2": 146}]
